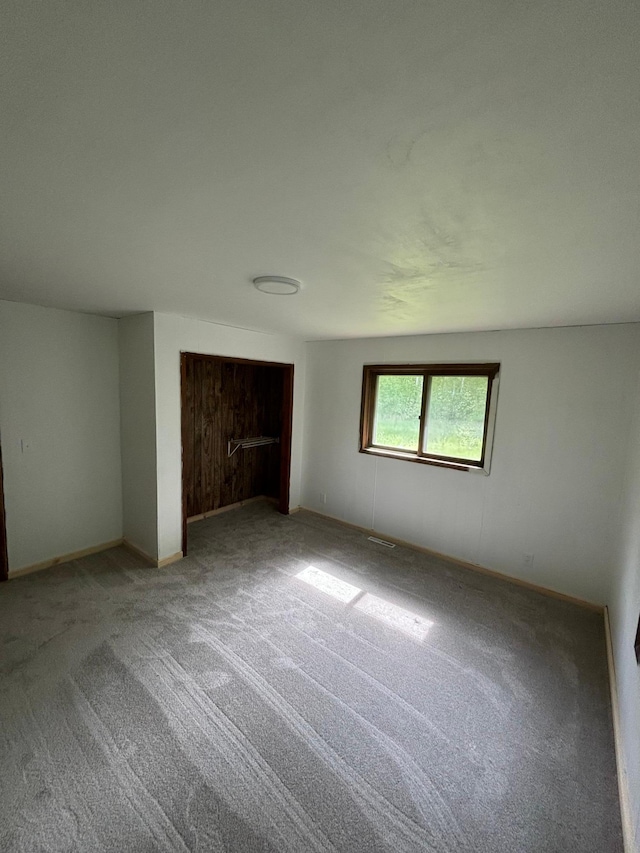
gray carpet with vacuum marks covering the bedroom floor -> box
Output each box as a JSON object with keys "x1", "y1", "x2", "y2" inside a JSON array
[{"x1": 0, "y1": 503, "x2": 622, "y2": 853}]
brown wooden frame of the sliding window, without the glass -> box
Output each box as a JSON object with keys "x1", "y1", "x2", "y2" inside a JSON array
[{"x1": 359, "y1": 362, "x2": 500, "y2": 473}]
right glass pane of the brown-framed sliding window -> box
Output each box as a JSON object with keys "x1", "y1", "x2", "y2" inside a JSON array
[{"x1": 425, "y1": 376, "x2": 489, "y2": 462}]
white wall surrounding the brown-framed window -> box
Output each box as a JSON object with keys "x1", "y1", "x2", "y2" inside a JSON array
[{"x1": 302, "y1": 324, "x2": 640, "y2": 603}]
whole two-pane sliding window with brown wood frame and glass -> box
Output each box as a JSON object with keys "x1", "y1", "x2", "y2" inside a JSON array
[{"x1": 360, "y1": 364, "x2": 500, "y2": 472}]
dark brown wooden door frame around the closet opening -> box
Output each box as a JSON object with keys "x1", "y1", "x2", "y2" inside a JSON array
[{"x1": 180, "y1": 352, "x2": 294, "y2": 557}]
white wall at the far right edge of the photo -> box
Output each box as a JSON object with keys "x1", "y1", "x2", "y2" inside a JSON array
[{"x1": 609, "y1": 360, "x2": 640, "y2": 850}]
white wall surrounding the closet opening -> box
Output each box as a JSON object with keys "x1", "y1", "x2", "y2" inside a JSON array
[{"x1": 154, "y1": 314, "x2": 305, "y2": 559}]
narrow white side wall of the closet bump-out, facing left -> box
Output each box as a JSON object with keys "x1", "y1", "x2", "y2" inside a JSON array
[{"x1": 119, "y1": 313, "x2": 158, "y2": 558}]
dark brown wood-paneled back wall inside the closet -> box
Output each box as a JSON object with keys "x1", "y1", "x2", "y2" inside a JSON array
[{"x1": 182, "y1": 353, "x2": 284, "y2": 518}]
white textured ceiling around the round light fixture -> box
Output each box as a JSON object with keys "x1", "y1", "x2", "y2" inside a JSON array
[{"x1": 0, "y1": 0, "x2": 640, "y2": 338}]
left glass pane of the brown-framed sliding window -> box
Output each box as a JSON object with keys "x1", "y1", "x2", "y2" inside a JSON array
[{"x1": 373, "y1": 376, "x2": 423, "y2": 451}]
